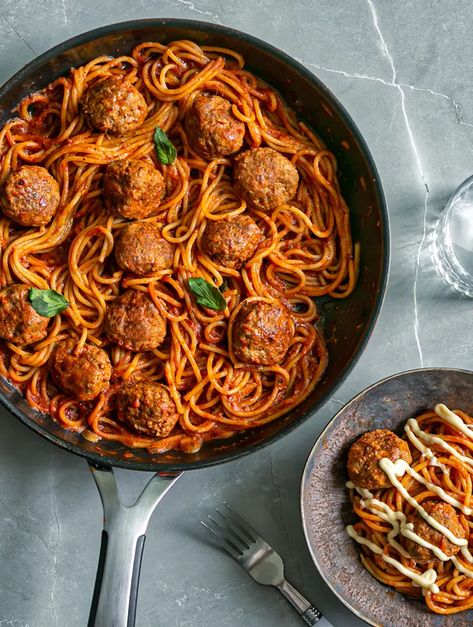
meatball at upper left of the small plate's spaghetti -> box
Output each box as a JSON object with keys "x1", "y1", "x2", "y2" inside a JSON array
[{"x1": 347, "y1": 429, "x2": 412, "y2": 490}]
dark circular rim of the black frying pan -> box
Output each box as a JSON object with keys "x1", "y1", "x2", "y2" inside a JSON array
[{"x1": 0, "y1": 18, "x2": 391, "y2": 472}]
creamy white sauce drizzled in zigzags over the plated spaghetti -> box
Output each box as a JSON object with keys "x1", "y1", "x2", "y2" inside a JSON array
[{"x1": 346, "y1": 404, "x2": 473, "y2": 593}]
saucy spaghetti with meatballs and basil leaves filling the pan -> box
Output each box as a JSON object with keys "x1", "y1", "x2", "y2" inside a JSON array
[{"x1": 0, "y1": 41, "x2": 359, "y2": 453}]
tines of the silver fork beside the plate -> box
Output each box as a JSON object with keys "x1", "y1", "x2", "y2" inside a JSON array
[{"x1": 200, "y1": 503, "x2": 259, "y2": 560}]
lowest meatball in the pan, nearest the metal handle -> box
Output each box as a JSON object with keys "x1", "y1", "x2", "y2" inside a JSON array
[{"x1": 117, "y1": 381, "x2": 179, "y2": 438}]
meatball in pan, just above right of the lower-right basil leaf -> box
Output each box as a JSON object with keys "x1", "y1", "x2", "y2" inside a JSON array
[{"x1": 201, "y1": 215, "x2": 263, "y2": 270}]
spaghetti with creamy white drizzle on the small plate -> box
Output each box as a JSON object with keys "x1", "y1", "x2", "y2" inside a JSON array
[{"x1": 347, "y1": 405, "x2": 473, "y2": 614}]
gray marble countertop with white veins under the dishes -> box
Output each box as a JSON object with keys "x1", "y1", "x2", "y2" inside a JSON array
[{"x1": 0, "y1": 0, "x2": 473, "y2": 627}]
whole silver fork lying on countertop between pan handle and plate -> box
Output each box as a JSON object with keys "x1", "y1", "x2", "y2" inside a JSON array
[{"x1": 201, "y1": 503, "x2": 330, "y2": 627}]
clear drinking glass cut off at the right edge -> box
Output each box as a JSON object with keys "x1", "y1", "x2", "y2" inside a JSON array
[{"x1": 432, "y1": 176, "x2": 473, "y2": 298}]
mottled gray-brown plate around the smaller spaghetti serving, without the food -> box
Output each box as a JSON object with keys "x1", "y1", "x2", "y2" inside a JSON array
[{"x1": 301, "y1": 368, "x2": 473, "y2": 627}]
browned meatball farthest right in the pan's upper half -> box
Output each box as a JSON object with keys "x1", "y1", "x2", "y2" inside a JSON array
[{"x1": 235, "y1": 148, "x2": 299, "y2": 211}]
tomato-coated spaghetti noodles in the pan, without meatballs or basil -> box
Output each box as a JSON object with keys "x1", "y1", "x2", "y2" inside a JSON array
[{"x1": 0, "y1": 41, "x2": 358, "y2": 453}]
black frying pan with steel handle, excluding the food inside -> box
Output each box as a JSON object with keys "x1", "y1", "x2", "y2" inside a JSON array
[{"x1": 0, "y1": 19, "x2": 389, "y2": 627}]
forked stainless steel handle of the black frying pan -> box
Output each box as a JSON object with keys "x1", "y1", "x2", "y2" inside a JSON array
[{"x1": 88, "y1": 463, "x2": 182, "y2": 627}]
